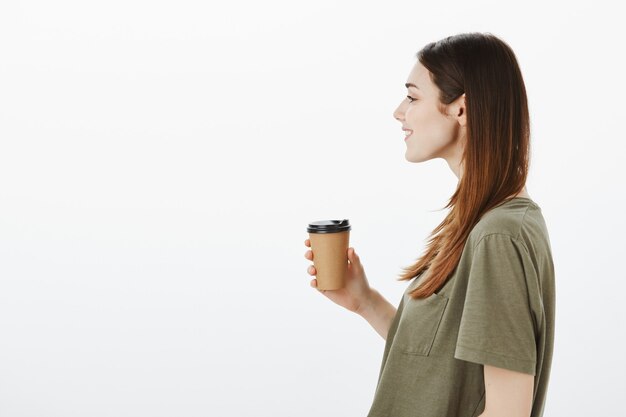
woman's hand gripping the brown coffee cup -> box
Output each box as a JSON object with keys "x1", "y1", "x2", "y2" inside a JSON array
[{"x1": 304, "y1": 239, "x2": 373, "y2": 313}]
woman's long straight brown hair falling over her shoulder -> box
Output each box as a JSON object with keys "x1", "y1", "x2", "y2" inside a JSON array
[{"x1": 398, "y1": 33, "x2": 530, "y2": 299}]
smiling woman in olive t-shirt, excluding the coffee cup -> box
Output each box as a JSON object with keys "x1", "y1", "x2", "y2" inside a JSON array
[{"x1": 305, "y1": 33, "x2": 555, "y2": 417}]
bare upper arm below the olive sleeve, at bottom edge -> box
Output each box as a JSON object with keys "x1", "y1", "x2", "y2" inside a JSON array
[{"x1": 478, "y1": 365, "x2": 535, "y2": 417}]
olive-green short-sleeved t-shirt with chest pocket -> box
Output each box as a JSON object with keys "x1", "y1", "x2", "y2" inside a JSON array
[{"x1": 368, "y1": 197, "x2": 555, "y2": 417}]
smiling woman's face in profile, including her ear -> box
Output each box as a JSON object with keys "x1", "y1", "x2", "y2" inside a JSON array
[{"x1": 393, "y1": 60, "x2": 466, "y2": 167}]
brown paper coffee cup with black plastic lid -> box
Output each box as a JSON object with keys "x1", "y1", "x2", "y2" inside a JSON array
[{"x1": 307, "y1": 219, "x2": 352, "y2": 290}]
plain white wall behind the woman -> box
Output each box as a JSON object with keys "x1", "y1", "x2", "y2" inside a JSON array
[{"x1": 0, "y1": 0, "x2": 626, "y2": 417}]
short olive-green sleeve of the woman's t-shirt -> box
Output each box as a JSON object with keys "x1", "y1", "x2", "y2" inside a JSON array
[{"x1": 454, "y1": 234, "x2": 537, "y2": 375}]
